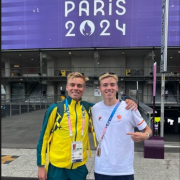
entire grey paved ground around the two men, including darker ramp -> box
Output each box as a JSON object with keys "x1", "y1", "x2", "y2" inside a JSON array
[{"x1": 1, "y1": 110, "x2": 180, "y2": 180}]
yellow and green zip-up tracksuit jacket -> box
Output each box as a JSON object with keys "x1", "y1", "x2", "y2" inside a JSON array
[{"x1": 37, "y1": 97, "x2": 96, "y2": 169}]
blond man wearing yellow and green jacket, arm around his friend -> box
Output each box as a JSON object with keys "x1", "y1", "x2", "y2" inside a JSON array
[{"x1": 37, "y1": 72, "x2": 136, "y2": 180}]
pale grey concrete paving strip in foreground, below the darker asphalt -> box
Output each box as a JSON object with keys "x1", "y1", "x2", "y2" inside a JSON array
[{"x1": 1, "y1": 148, "x2": 180, "y2": 180}]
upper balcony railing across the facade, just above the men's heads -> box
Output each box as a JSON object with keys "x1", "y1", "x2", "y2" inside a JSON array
[{"x1": 1, "y1": 66, "x2": 180, "y2": 77}]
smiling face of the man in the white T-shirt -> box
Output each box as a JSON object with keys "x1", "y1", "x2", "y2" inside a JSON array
[{"x1": 99, "y1": 77, "x2": 118, "y2": 101}]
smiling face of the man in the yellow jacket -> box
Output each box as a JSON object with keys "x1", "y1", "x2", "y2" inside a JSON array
[{"x1": 66, "y1": 77, "x2": 85, "y2": 101}]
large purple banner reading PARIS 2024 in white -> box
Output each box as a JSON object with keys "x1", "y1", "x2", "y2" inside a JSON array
[{"x1": 1, "y1": 0, "x2": 180, "y2": 50}]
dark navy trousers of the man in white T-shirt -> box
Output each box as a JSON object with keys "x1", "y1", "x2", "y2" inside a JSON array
[{"x1": 94, "y1": 173, "x2": 134, "y2": 180}]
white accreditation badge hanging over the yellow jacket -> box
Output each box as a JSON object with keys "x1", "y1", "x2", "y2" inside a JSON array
[{"x1": 71, "y1": 141, "x2": 83, "y2": 163}]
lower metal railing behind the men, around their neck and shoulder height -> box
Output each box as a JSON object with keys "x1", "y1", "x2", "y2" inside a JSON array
[{"x1": 1, "y1": 94, "x2": 180, "y2": 117}]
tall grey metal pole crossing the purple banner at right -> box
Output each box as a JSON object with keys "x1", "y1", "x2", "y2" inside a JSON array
[{"x1": 160, "y1": 0, "x2": 169, "y2": 137}]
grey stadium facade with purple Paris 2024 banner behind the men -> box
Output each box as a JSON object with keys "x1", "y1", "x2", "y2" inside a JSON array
[{"x1": 1, "y1": 0, "x2": 180, "y2": 134}]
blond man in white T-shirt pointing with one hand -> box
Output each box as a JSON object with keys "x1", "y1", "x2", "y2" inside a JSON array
[{"x1": 92, "y1": 73, "x2": 152, "y2": 180}]
